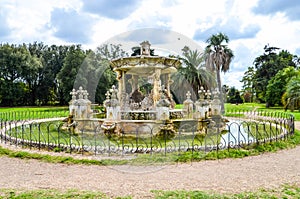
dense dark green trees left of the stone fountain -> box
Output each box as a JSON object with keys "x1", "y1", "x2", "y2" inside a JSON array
[{"x1": 0, "y1": 42, "x2": 125, "y2": 106}]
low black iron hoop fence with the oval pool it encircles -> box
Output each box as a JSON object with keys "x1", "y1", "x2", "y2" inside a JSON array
[{"x1": 0, "y1": 111, "x2": 294, "y2": 159}]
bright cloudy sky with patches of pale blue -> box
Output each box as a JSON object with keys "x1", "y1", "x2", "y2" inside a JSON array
[{"x1": 0, "y1": 0, "x2": 300, "y2": 89}]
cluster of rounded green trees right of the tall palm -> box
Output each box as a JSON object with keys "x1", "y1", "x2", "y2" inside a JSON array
[{"x1": 241, "y1": 45, "x2": 300, "y2": 109}]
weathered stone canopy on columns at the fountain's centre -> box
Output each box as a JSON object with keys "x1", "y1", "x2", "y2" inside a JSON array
[{"x1": 111, "y1": 41, "x2": 181, "y2": 115}]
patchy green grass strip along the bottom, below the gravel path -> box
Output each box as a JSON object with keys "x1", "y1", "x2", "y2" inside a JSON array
[{"x1": 0, "y1": 184, "x2": 300, "y2": 199}]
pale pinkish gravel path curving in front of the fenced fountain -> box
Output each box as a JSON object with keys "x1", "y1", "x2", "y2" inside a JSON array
[{"x1": 0, "y1": 122, "x2": 300, "y2": 198}]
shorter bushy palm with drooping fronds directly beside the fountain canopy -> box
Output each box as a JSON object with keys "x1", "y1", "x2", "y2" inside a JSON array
[{"x1": 173, "y1": 46, "x2": 215, "y2": 101}]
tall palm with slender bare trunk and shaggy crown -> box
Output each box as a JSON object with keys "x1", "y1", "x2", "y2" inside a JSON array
[{"x1": 205, "y1": 33, "x2": 234, "y2": 113}]
